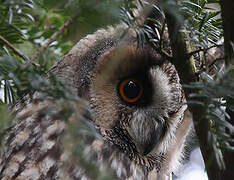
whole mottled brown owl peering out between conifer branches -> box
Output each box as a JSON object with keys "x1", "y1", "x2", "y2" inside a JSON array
[{"x1": 0, "y1": 21, "x2": 191, "y2": 180}]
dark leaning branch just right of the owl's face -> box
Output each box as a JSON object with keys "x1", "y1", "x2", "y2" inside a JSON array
[{"x1": 165, "y1": 2, "x2": 221, "y2": 180}]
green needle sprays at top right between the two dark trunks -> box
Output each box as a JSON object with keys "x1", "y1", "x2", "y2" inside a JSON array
[{"x1": 179, "y1": 0, "x2": 223, "y2": 48}]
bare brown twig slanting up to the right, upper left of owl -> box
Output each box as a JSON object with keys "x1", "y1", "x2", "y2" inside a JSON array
[{"x1": 31, "y1": 17, "x2": 74, "y2": 62}]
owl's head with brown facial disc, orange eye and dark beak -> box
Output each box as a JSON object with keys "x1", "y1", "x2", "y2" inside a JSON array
[{"x1": 54, "y1": 26, "x2": 186, "y2": 172}]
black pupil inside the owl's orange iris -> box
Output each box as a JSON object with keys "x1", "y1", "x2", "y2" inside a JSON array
[{"x1": 123, "y1": 81, "x2": 141, "y2": 99}]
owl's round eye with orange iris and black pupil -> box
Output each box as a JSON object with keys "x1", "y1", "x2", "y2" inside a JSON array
[{"x1": 119, "y1": 78, "x2": 143, "y2": 103}]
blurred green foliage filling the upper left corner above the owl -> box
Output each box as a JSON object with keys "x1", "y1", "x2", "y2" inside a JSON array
[{"x1": 0, "y1": 0, "x2": 122, "y2": 60}]
